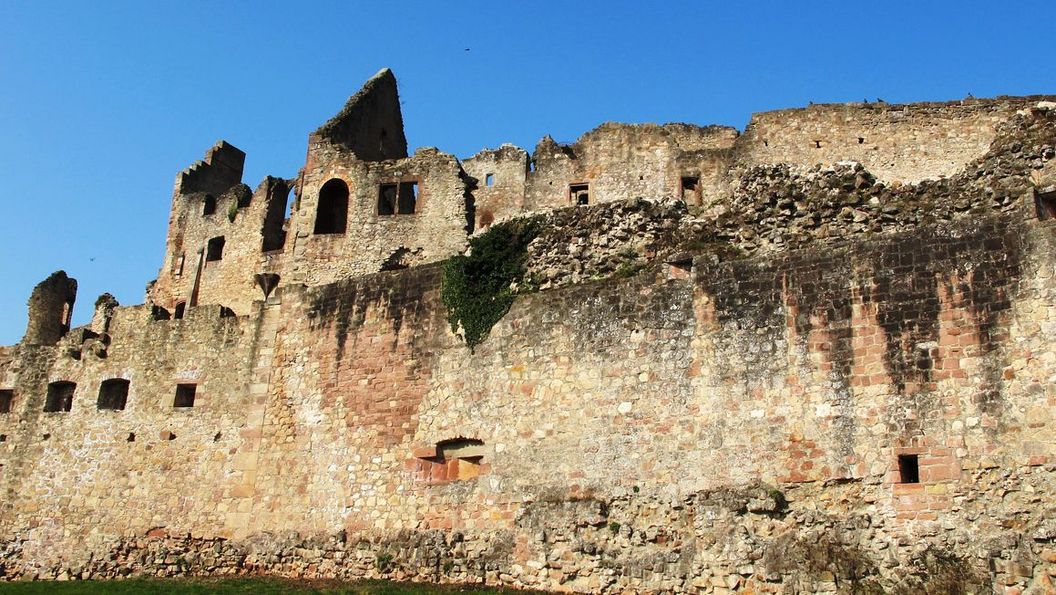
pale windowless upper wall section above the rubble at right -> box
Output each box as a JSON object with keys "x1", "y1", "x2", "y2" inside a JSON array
[{"x1": 737, "y1": 97, "x2": 1038, "y2": 184}]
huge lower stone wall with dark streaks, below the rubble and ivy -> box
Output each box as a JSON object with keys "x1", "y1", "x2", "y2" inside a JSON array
[{"x1": 0, "y1": 209, "x2": 1056, "y2": 592}]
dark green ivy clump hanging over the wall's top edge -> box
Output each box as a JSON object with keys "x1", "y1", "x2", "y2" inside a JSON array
[{"x1": 440, "y1": 219, "x2": 540, "y2": 350}]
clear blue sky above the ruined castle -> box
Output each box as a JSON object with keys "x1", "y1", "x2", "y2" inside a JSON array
[{"x1": 0, "y1": 0, "x2": 1056, "y2": 345}]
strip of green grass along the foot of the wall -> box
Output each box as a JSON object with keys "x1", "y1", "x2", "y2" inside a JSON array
[{"x1": 0, "y1": 578, "x2": 539, "y2": 595}]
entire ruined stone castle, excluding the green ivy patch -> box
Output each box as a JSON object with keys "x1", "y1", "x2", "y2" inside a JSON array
[{"x1": 0, "y1": 70, "x2": 1056, "y2": 593}]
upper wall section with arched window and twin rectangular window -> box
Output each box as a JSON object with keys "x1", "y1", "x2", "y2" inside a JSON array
[{"x1": 284, "y1": 144, "x2": 467, "y2": 285}]
